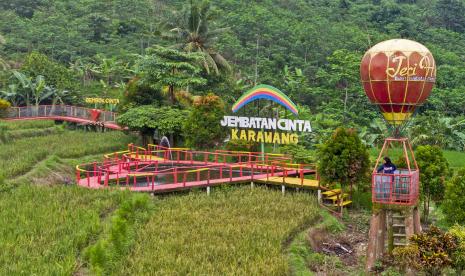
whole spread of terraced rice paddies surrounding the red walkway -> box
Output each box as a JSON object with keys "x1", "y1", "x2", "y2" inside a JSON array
[{"x1": 0, "y1": 122, "x2": 319, "y2": 275}]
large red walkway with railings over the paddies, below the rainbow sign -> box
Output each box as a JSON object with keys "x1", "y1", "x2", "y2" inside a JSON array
[{"x1": 76, "y1": 144, "x2": 318, "y2": 191}]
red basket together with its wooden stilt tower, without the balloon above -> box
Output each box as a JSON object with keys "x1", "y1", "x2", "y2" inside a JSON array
[{"x1": 366, "y1": 138, "x2": 421, "y2": 271}]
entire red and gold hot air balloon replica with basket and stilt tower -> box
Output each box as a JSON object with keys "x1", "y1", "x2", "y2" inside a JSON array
[{"x1": 360, "y1": 39, "x2": 436, "y2": 270}]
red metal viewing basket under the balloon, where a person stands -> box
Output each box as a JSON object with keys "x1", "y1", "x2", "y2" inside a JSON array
[{"x1": 372, "y1": 138, "x2": 419, "y2": 208}]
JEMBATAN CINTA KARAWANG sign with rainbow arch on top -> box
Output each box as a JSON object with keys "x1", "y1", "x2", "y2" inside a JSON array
[{"x1": 221, "y1": 85, "x2": 312, "y2": 144}]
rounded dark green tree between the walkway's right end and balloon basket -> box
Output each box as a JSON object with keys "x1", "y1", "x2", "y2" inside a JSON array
[{"x1": 317, "y1": 128, "x2": 370, "y2": 192}]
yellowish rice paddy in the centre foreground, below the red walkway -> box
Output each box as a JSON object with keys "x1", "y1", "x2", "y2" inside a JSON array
[{"x1": 120, "y1": 187, "x2": 318, "y2": 275}]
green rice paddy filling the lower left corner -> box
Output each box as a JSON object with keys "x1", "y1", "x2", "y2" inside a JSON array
[{"x1": 0, "y1": 185, "x2": 130, "y2": 275}]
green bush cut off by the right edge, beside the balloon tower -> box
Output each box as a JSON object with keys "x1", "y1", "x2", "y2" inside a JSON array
[{"x1": 442, "y1": 168, "x2": 465, "y2": 224}]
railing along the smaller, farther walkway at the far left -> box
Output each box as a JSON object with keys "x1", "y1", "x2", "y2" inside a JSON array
[{"x1": 6, "y1": 105, "x2": 117, "y2": 122}]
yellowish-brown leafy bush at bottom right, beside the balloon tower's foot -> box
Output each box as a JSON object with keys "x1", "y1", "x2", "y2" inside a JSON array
[{"x1": 392, "y1": 226, "x2": 457, "y2": 275}]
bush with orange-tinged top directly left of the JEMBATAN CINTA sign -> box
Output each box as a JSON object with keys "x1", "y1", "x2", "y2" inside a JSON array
[{"x1": 184, "y1": 93, "x2": 226, "y2": 149}]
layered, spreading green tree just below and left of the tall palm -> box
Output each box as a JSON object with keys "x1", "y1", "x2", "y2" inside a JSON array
[{"x1": 137, "y1": 46, "x2": 206, "y2": 105}]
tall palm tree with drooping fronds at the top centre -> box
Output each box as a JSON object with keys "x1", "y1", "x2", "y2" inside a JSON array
[{"x1": 167, "y1": 0, "x2": 231, "y2": 74}]
